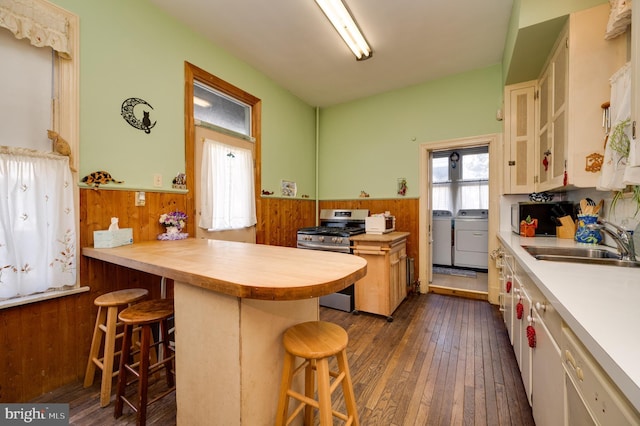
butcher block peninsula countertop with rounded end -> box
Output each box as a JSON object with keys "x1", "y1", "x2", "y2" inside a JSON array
[{"x1": 82, "y1": 238, "x2": 367, "y2": 300}]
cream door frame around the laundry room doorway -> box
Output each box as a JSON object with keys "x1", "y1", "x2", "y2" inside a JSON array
[{"x1": 418, "y1": 133, "x2": 502, "y2": 304}]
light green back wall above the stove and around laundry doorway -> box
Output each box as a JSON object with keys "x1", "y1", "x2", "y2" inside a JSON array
[{"x1": 318, "y1": 64, "x2": 502, "y2": 199}]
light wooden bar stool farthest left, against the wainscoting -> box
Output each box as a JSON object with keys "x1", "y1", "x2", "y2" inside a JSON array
[{"x1": 84, "y1": 288, "x2": 149, "y2": 407}]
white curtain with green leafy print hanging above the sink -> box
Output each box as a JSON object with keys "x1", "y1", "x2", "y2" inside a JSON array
[{"x1": 597, "y1": 62, "x2": 631, "y2": 191}]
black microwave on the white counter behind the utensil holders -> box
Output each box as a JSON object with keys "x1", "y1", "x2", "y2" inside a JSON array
[{"x1": 511, "y1": 201, "x2": 575, "y2": 237}]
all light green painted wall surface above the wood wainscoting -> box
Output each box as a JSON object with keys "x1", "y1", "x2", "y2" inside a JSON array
[{"x1": 54, "y1": 0, "x2": 603, "y2": 199}]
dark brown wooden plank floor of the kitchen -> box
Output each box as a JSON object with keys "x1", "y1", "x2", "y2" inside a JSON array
[{"x1": 34, "y1": 293, "x2": 534, "y2": 426}]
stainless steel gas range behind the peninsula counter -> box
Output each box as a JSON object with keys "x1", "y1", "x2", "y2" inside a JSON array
[{"x1": 297, "y1": 209, "x2": 369, "y2": 312}]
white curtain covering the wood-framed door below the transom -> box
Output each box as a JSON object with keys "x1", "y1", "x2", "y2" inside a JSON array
[{"x1": 199, "y1": 139, "x2": 256, "y2": 231}]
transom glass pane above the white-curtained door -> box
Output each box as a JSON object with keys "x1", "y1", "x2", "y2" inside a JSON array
[{"x1": 193, "y1": 83, "x2": 251, "y2": 136}]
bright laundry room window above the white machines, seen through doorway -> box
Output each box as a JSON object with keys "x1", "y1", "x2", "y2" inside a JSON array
[{"x1": 431, "y1": 147, "x2": 489, "y2": 215}]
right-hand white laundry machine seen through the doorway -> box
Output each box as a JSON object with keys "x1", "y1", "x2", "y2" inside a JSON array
[{"x1": 453, "y1": 209, "x2": 489, "y2": 269}]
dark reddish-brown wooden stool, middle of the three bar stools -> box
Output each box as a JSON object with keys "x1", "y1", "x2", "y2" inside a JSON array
[{"x1": 114, "y1": 299, "x2": 176, "y2": 425}]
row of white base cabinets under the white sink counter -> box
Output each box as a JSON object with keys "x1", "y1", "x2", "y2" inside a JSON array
[{"x1": 499, "y1": 241, "x2": 640, "y2": 426}]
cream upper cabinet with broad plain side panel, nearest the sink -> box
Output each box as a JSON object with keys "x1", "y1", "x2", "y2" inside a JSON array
[{"x1": 535, "y1": 3, "x2": 627, "y2": 191}]
